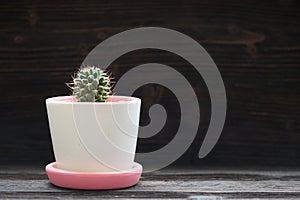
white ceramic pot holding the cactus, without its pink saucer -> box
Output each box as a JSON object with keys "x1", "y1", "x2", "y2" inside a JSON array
[{"x1": 46, "y1": 96, "x2": 141, "y2": 172}]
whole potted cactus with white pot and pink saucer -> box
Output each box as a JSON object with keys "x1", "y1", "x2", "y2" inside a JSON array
[{"x1": 46, "y1": 66, "x2": 142, "y2": 189}]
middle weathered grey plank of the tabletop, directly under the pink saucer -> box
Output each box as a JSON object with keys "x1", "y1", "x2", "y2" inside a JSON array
[{"x1": 0, "y1": 177, "x2": 300, "y2": 195}]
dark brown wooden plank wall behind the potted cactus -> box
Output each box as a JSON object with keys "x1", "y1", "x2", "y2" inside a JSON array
[{"x1": 0, "y1": 0, "x2": 300, "y2": 167}]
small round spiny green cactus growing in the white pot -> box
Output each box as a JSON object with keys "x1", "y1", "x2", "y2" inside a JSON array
[{"x1": 72, "y1": 66, "x2": 111, "y2": 102}]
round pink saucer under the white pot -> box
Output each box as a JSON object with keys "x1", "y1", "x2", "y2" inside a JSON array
[{"x1": 46, "y1": 162, "x2": 143, "y2": 190}]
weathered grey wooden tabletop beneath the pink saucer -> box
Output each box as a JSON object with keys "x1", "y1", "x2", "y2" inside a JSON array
[{"x1": 0, "y1": 167, "x2": 300, "y2": 199}]
